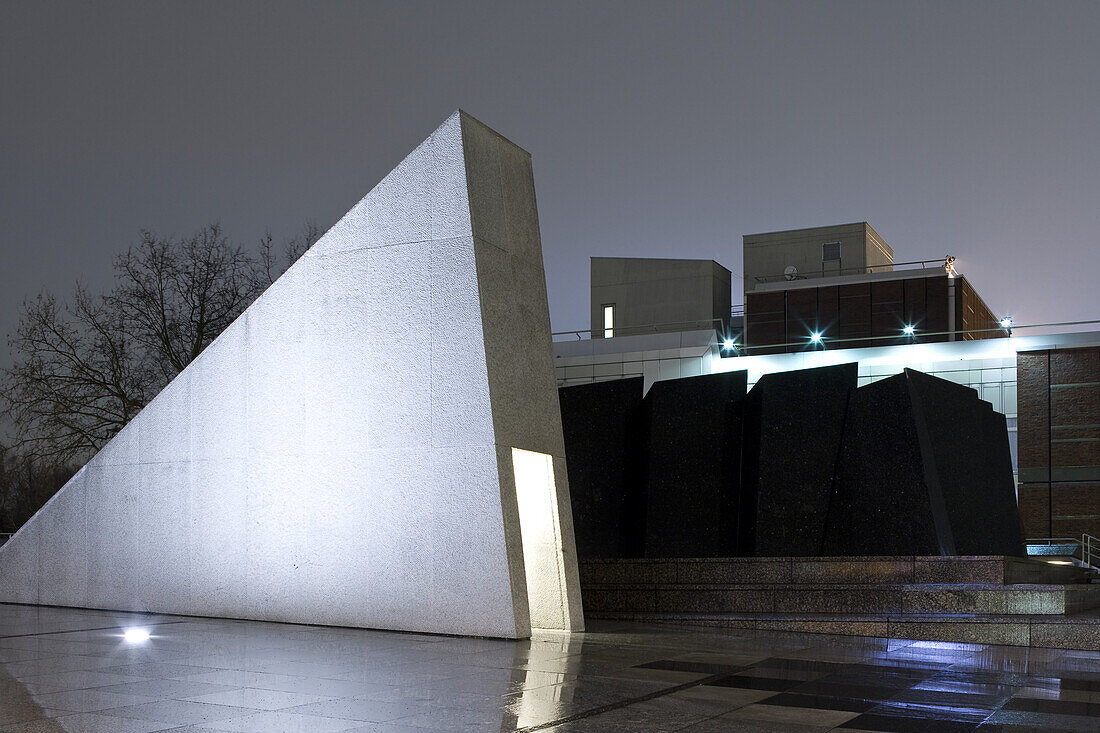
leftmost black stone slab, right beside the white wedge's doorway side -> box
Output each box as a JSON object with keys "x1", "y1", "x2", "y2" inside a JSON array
[{"x1": 558, "y1": 376, "x2": 645, "y2": 559}]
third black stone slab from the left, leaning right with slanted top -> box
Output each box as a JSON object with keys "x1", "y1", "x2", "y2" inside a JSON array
[{"x1": 738, "y1": 363, "x2": 857, "y2": 557}]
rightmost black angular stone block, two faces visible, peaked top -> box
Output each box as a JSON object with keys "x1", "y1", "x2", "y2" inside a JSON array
[{"x1": 824, "y1": 369, "x2": 1023, "y2": 555}]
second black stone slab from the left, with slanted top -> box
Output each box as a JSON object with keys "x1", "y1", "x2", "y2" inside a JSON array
[{"x1": 645, "y1": 372, "x2": 747, "y2": 557}]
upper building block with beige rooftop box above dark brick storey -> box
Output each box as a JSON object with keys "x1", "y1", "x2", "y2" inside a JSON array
[{"x1": 732, "y1": 221, "x2": 1004, "y2": 353}]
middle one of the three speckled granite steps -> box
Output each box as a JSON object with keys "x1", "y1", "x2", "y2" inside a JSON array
[{"x1": 581, "y1": 583, "x2": 1100, "y2": 615}]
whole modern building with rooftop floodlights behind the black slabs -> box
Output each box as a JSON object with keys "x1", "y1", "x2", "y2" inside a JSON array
[{"x1": 554, "y1": 222, "x2": 1100, "y2": 537}]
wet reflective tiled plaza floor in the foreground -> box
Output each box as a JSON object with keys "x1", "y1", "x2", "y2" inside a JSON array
[{"x1": 0, "y1": 605, "x2": 1100, "y2": 733}]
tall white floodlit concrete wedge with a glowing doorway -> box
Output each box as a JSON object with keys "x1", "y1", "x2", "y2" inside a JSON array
[{"x1": 0, "y1": 112, "x2": 583, "y2": 637}]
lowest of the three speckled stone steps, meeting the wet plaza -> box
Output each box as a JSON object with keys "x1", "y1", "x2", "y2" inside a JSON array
[{"x1": 585, "y1": 611, "x2": 1100, "y2": 650}]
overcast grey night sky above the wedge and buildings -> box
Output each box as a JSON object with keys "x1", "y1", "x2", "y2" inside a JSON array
[{"x1": 0, "y1": 0, "x2": 1100, "y2": 365}]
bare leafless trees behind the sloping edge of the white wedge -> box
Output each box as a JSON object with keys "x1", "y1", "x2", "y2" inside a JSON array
[{"x1": 0, "y1": 222, "x2": 320, "y2": 462}]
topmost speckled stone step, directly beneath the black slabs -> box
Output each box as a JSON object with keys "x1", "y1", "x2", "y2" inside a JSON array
[{"x1": 580, "y1": 556, "x2": 1092, "y2": 586}]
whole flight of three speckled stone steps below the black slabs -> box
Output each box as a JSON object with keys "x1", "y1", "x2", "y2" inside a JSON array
[{"x1": 581, "y1": 556, "x2": 1100, "y2": 649}]
